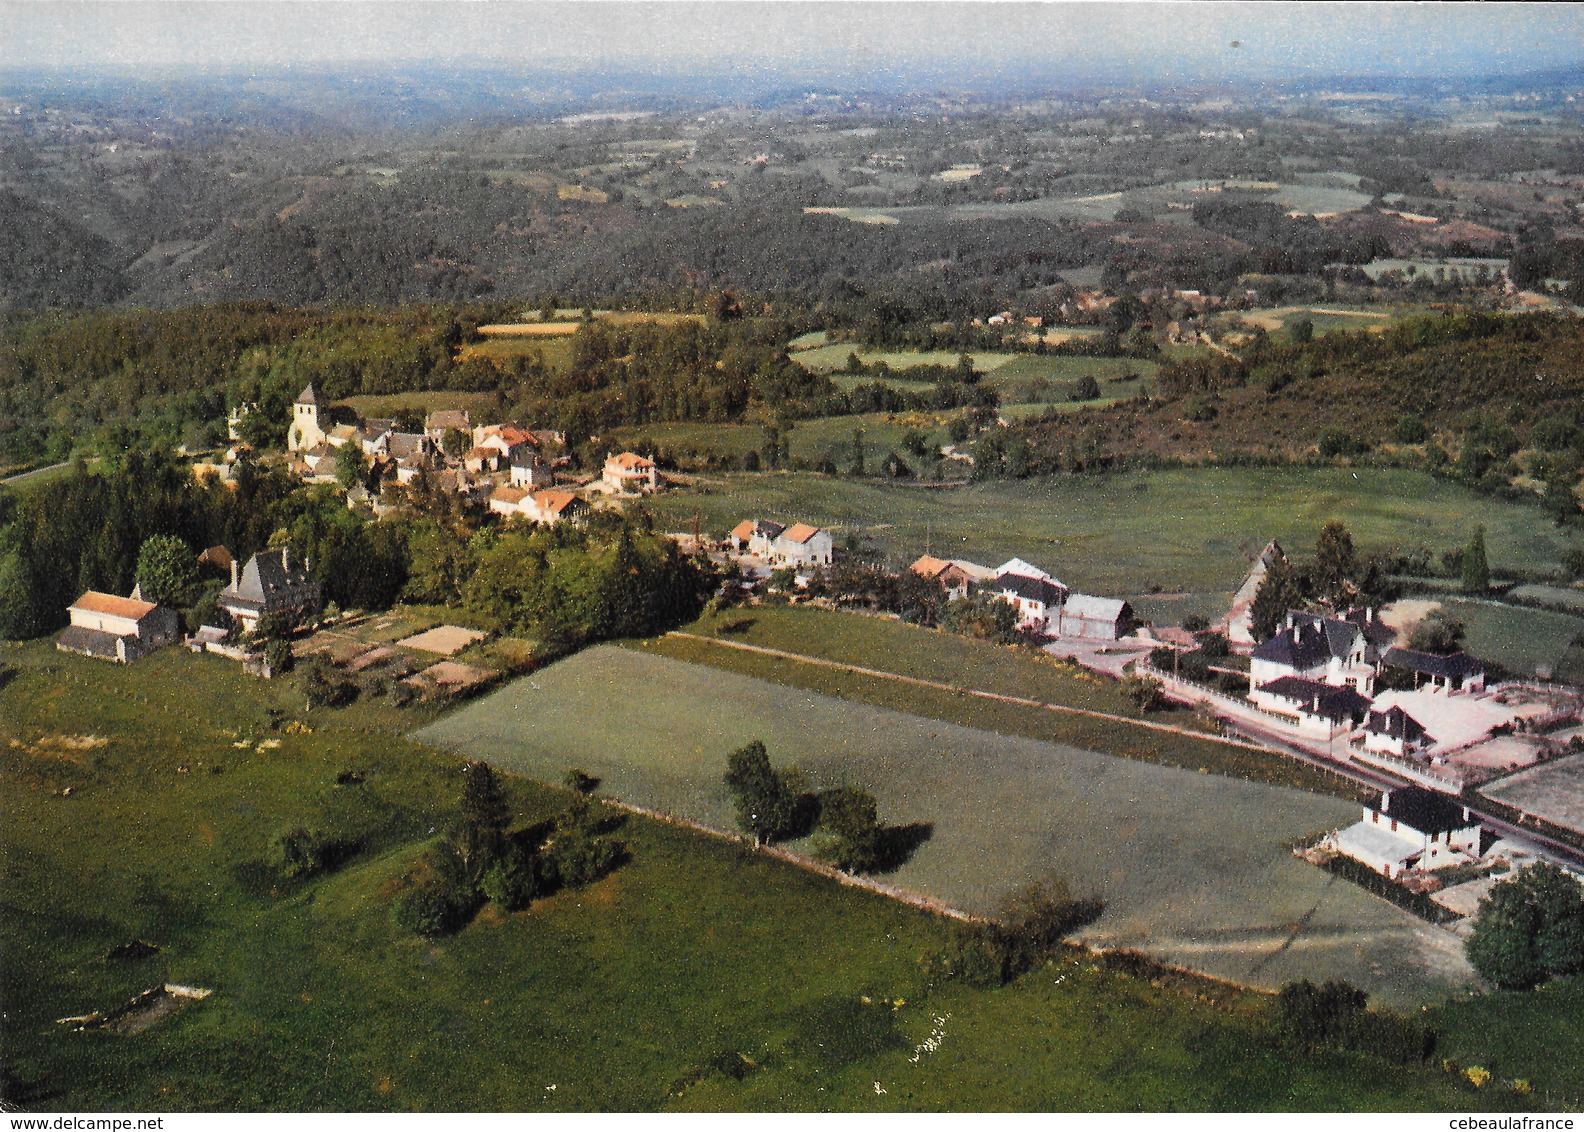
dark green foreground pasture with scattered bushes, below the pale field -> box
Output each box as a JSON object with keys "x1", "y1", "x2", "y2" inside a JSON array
[{"x1": 0, "y1": 641, "x2": 1526, "y2": 1111}]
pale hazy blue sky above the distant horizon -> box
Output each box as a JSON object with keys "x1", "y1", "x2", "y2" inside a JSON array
[{"x1": 0, "y1": 0, "x2": 1584, "y2": 81}]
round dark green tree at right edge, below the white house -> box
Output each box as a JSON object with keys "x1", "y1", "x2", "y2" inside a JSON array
[{"x1": 1464, "y1": 863, "x2": 1584, "y2": 988}]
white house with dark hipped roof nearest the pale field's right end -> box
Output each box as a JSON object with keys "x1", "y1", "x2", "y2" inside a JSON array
[{"x1": 1329, "y1": 787, "x2": 1479, "y2": 879}]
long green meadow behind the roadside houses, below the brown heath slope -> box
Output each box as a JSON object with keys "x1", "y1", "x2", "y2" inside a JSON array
[{"x1": 654, "y1": 468, "x2": 1567, "y2": 595}]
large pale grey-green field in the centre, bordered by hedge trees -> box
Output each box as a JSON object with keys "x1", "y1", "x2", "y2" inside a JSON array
[{"x1": 413, "y1": 648, "x2": 1472, "y2": 1002}]
